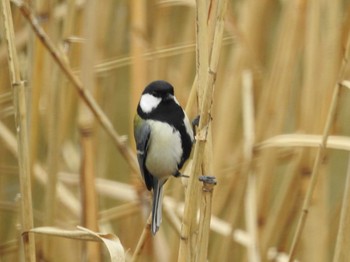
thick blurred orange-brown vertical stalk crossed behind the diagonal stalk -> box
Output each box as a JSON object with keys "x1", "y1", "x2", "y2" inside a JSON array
[{"x1": 78, "y1": 0, "x2": 101, "y2": 262}]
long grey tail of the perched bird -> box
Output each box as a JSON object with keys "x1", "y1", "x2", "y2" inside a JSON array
[{"x1": 151, "y1": 179, "x2": 164, "y2": 235}]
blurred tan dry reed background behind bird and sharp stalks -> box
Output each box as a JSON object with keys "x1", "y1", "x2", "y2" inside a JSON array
[{"x1": 0, "y1": 0, "x2": 350, "y2": 261}]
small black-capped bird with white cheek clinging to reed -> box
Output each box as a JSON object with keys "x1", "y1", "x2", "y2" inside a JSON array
[{"x1": 134, "y1": 80, "x2": 194, "y2": 235}]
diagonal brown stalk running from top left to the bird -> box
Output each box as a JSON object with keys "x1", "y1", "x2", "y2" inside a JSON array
[{"x1": 15, "y1": 1, "x2": 139, "y2": 176}]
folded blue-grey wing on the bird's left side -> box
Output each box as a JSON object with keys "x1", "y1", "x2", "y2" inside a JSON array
[{"x1": 134, "y1": 118, "x2": 153, "y2": 190}]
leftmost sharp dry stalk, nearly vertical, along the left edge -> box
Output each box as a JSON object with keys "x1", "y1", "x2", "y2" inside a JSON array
[{"x1": 1, "y1": 0, "x2": 36, "y2": 262}]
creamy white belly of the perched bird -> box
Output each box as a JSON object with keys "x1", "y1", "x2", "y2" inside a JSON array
[{"x1": 146, "y1": 120, "x2": 182, "y2": 178}]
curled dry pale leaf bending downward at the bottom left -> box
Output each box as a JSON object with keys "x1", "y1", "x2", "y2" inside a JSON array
[{"x1": 29, "y1": 226, "x2": 125, "y2": 262}]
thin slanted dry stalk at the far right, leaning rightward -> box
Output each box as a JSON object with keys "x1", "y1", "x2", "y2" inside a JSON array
[{"x1": 289, "y1": 33, "x2": 350, "y2": 261}]
